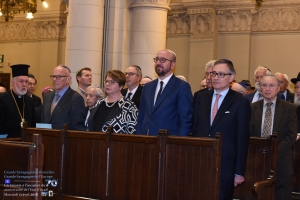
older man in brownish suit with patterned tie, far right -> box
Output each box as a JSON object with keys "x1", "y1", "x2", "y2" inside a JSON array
[{"x1": 250, "y1": 75, "x2": 297, "y2": 200}]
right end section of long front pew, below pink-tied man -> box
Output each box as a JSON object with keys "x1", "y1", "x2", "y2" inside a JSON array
[{"x1": 160, "y1": 134, "x2": 222, "y2": 200}]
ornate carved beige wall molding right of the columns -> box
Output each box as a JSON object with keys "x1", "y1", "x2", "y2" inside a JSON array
[{"x1": 167, "y1": 0, "x2": 300, "y2": 39}]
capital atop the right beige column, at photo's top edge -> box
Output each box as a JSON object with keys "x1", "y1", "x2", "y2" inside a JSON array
[{"x1": 129, "y1": 0, "x2": 171, "y2": 10}]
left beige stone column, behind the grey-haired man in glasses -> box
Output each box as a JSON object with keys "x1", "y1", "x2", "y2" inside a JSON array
[{"x1": 66, "y1": 0, "x2": 104, "y2": 89}]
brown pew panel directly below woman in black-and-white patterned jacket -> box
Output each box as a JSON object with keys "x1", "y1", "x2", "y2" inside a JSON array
[{"x1": 108, "y1": 134, "x2": 158, "y2": 200}]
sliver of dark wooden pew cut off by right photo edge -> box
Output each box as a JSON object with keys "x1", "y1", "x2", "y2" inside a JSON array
[{"x1": 292, "y1": 140, "x2": 300, "y2": 199}]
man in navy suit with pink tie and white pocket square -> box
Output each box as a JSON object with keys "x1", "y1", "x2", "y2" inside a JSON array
[{"x1": 192, "y1": 59, "x2": 251, "y2": 200}]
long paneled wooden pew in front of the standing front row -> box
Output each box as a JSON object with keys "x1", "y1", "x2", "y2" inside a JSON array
[{"x1": 24, "y1": 128, "x2": 221, "y2": 200}]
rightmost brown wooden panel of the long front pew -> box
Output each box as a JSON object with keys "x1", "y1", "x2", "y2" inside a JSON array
[{"x1": 165, "y1": 141, "x2": 217, "y2": 200}]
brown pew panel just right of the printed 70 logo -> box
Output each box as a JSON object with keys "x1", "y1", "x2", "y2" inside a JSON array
[{"x1": 63, "y1": 131, "x2": 107, "y2": 199}]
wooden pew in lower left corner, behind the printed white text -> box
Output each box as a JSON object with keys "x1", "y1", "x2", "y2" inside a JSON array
[{"x1": 0, "y1": 135, "x2": 44, "y2": 200}]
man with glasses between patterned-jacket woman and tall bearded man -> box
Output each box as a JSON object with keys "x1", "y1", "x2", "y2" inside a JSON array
[{"x1": 121, "y1": 65, "x2": 143, "y2": 109}]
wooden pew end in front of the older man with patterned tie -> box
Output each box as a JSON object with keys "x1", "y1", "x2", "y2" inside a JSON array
[{"x1": 234, "y1": 133, "x2": 278, "y2": 200}]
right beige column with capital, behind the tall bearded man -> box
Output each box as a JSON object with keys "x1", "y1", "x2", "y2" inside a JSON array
[{"x1": 129, "y1": 0, "x2": 170, "y2": 78}]
